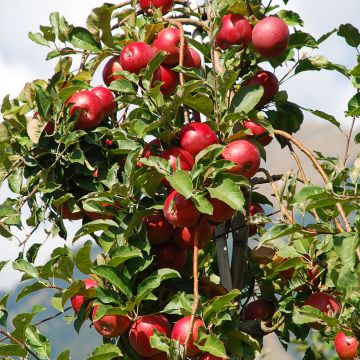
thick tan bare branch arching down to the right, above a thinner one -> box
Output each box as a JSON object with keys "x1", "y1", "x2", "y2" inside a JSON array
[{"x1": 274, "y1": 129, "x2": 352, "y2": 232}]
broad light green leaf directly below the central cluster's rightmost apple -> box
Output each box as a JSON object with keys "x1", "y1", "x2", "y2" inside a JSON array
[{"x1": 207, "y1": 178, "x2": 245, "y2": 210}]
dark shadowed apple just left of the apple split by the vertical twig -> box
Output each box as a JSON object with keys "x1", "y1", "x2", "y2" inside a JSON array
[{"x1": 143, "y1": 213, "x2": 174, "y2": 244}]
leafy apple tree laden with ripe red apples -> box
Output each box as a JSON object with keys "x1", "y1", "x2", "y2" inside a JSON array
[{"x1": 0, "y1": 0, "x2": 360, "y2": 360}]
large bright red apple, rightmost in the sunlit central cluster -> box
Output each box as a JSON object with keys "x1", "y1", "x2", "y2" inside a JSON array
[{"x1": 221, "y1": 140, "x2": 260, "y2": 179}]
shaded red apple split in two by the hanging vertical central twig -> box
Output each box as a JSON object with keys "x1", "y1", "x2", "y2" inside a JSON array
[{"x1": 173, "y1": 217, "x2": 214, "y2": 250}]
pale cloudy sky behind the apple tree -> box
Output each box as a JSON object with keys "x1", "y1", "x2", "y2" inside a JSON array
[{"x1": 0, "y1": 0, "x2": 360, "y2": 289}]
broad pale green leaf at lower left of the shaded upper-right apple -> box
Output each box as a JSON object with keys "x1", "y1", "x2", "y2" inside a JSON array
[{"x1": 230, "y1": 85, "x2": 264, "y2": 114}]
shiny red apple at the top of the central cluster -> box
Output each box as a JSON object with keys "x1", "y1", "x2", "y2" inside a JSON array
[{"x1": 178, "y1": 122, "x2": 218, "y2": 157}]
